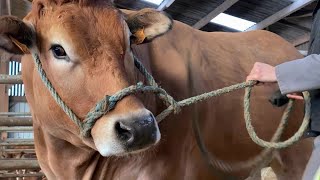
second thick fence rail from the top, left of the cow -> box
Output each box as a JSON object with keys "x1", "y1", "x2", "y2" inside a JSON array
[{"x1": 0, "y1": 116, "x2": 32, "y2": 126}]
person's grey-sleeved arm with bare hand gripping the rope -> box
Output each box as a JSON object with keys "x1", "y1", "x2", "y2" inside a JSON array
[{"x1": 247, "y1": 54, "x2": 320, "y2": 99}]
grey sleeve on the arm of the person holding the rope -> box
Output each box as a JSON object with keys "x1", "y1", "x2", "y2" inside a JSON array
[{"x1": 276, "y1": 54, "x2": 320, "y2": 94}]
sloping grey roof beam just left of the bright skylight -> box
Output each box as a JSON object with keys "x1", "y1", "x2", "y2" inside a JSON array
[{"x1": 193, "y1": 0, "x2": 239, "y2": 29}]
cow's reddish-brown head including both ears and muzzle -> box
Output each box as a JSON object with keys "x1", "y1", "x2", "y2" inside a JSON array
[{"x1": 0, "y1": 0, "x2": 172, "y2": 156}]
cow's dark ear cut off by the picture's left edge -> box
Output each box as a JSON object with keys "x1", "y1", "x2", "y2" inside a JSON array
[{"x1": 0, "y1": 16, "x2": 35, "y2": 54}]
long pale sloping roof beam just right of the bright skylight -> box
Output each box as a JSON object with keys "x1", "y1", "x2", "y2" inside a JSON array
[{"x1": 246, "y1": 0, "x2": 315, "y2": 31}]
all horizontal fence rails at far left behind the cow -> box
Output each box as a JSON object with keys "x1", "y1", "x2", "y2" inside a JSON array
[{"x1": 0, "y1": 74, "x2": 44, "y2": 179}]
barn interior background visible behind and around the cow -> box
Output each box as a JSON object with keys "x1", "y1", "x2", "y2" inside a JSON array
[{"x1": 0, "y1": 0, "x2": 317, "y2": 179}]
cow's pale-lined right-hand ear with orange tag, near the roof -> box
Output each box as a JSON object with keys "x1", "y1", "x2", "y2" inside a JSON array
[{"x1": 126, "y1": 8, "x2": 173, "y2": 44}]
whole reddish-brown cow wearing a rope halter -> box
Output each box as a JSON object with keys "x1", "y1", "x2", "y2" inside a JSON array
[{"x1": 0, "y1": 0, "x2": 311, "y2": 180}]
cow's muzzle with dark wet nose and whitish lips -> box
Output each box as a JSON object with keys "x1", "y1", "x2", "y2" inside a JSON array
[{"x1": 91, "y1": 109, "x2": 160, "y2": 156}]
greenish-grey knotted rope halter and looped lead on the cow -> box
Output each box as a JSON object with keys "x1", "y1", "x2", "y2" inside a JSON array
[{"x1": 32, "y1": 49, "x2": 311, "y2": 172}]
